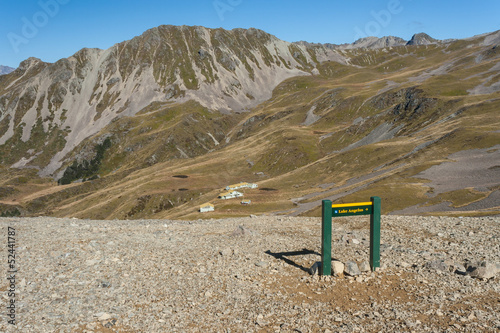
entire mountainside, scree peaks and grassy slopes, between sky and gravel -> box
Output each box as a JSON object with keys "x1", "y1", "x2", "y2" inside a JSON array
[{"x1": 0, "y1": 26, "x2": 500, "y2": 218}]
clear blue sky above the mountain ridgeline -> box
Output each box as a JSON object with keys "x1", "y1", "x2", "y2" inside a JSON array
[{"x1": 0, "y1": 0, "x2": 500, "y2": 67}]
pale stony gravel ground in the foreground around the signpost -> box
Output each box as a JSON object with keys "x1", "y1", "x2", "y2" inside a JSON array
[{"x1": 0, "y1": 216, "x2": 500, "y2": 332}]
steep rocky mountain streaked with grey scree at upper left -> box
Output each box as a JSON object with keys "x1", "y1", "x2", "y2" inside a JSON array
[{"x1": 0, "y1": 26, "x2": 344, "y2": 176}]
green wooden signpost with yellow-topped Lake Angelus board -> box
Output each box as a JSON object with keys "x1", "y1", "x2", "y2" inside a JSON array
[{"x1": 321, "y1": 197, "x2": 380, "y2": 275}]
